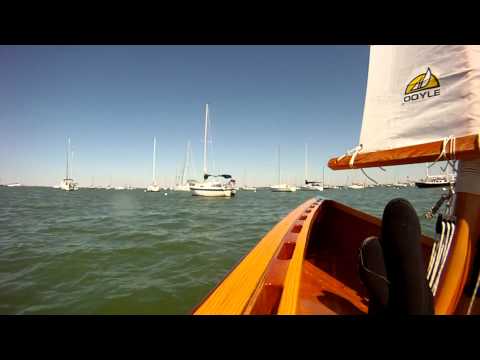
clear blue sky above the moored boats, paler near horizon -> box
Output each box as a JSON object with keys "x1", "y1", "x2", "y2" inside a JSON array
[{"x1": 0, "y1": 46, "x2": 446, "y2": 186}]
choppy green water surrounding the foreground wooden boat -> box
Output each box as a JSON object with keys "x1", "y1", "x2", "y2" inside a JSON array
[{"x1": 0, "y1": 187, "x2": 442, "y2": 314}]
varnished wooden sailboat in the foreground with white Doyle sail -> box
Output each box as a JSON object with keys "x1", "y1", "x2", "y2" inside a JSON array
[{"x1": 193, "y1": 45, "x2": 480, "y2": 315}]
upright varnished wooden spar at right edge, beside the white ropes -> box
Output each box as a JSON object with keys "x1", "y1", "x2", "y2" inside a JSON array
[{"x1": 435, "y1": 192, "x2": 480, "y2": 315}]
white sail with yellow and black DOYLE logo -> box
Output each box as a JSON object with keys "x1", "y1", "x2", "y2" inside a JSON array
[{"x1": 359, "y1": 45, "x2": 480, "y2": 153}]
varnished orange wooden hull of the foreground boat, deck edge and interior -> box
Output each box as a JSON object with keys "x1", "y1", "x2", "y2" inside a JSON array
[{"x1": 194, "y1": 199, "x2": 433, "y2": 315}]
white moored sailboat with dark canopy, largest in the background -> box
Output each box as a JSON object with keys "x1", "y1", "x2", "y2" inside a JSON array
[{"x1": 190, "y1": 104, "x2": 236, "y2": 197}]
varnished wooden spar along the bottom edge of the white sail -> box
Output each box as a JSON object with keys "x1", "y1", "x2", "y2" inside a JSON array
[{"x1": 328, "y1": 134, "x2": 480, "y2": 170}]
